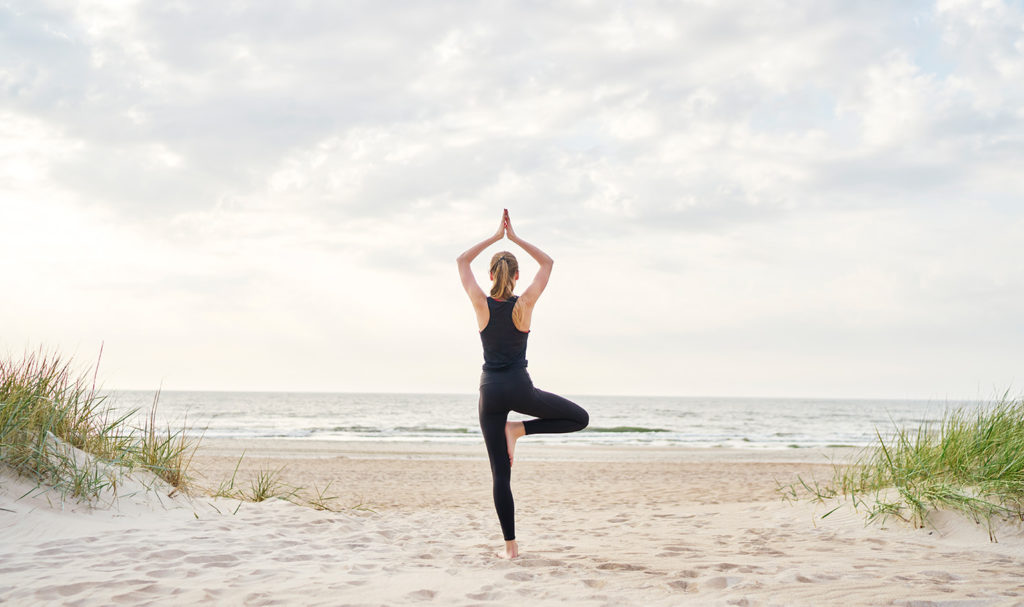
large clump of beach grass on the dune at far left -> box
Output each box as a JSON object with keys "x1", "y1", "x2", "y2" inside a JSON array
[{"x1": 0, "y1": 351, "x2": 199, "y2": 500}]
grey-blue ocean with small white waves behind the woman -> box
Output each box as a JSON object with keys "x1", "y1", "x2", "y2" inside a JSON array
[{"x1": 108, "y1": 391, "x2": 981, "y2": 449}]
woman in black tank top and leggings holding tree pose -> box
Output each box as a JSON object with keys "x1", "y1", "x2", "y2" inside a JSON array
[{"x1": 457, "y1": 209, "x2": 590, "y2": 559}]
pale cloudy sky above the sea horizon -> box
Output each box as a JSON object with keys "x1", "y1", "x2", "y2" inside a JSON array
[{"x1": 0, "y1": 0, "x2": 1024, "y2": 400}]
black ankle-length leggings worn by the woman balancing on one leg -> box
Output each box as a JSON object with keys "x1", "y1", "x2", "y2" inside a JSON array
[{"x1": 479, "y1": 368, "x2": 590, "y2": 540}]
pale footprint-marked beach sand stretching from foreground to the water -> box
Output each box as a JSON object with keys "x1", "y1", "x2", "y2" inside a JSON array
[{"x1": 0, "y1": 439, "x2": 1024, "y2": 606}]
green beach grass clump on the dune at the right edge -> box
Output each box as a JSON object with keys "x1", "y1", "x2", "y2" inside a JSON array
[{"x1": 780, "y1": 396, "x2": 1024, "y2": 540}]
